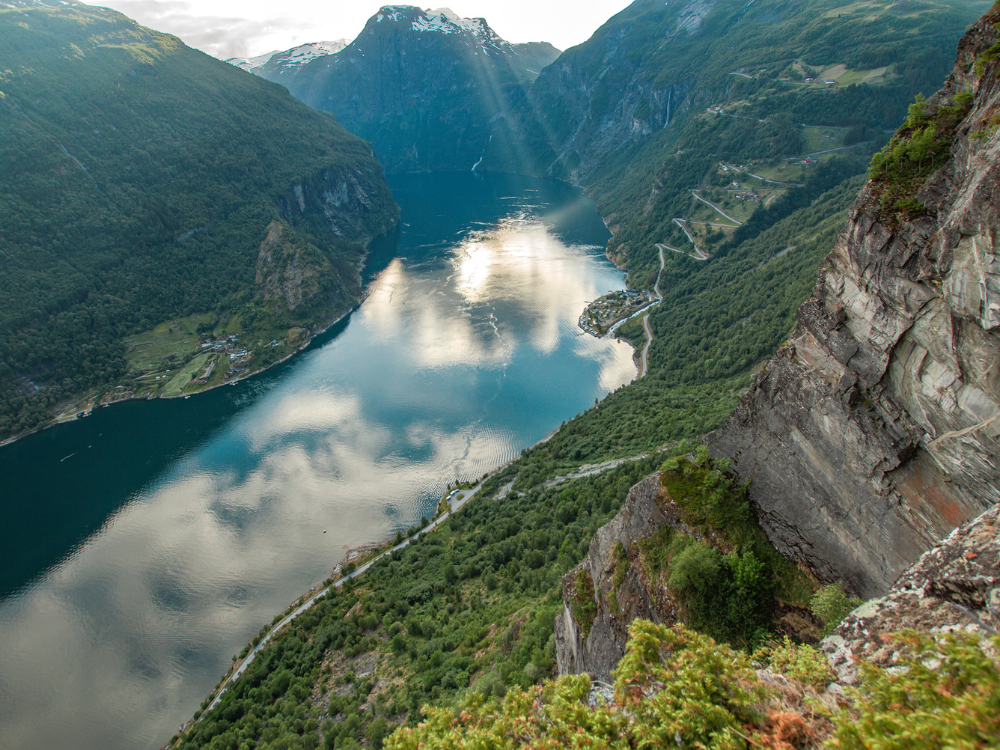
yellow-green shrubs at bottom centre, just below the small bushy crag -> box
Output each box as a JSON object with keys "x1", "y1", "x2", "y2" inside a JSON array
[{"x1": 386, "y1": 620, "x2": 766, "y2": 750}]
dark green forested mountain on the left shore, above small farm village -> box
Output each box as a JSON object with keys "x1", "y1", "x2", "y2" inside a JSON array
[{"x1": 0, "y1": 3, "x2": 398, "y2": 437}]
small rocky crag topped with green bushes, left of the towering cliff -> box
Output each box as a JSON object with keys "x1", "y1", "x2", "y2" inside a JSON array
[{"x1": 555, "y1": 472, "x2": 819, "y2": 682}]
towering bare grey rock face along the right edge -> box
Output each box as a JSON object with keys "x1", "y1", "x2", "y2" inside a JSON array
[{"x1": 709, "y1": 10, "x2": 1000, "y2": 597}]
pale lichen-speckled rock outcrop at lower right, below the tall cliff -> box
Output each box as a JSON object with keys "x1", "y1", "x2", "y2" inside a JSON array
[{"x1": 822, "y1": 508, "x2": 1000, "y2": 685}]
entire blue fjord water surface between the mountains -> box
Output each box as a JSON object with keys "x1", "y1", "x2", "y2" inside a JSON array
[{"x1": 0, "y1": 174, "x2": 635, "y2": 750}]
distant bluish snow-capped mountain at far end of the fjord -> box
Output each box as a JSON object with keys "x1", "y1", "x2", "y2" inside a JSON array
[{"x1": 254, "y1": 6, "x2": 558, "y2": 172}]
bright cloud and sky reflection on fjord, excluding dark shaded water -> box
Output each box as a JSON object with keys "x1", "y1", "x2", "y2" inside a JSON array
[{"x1": 0, "y1": 172, "x2": 635, "y2": 748}]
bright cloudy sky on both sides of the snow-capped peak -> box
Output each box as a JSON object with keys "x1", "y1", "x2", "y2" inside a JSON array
[{"x1": 88, "y1": 0, "x2": 631, "y2": 60}]
